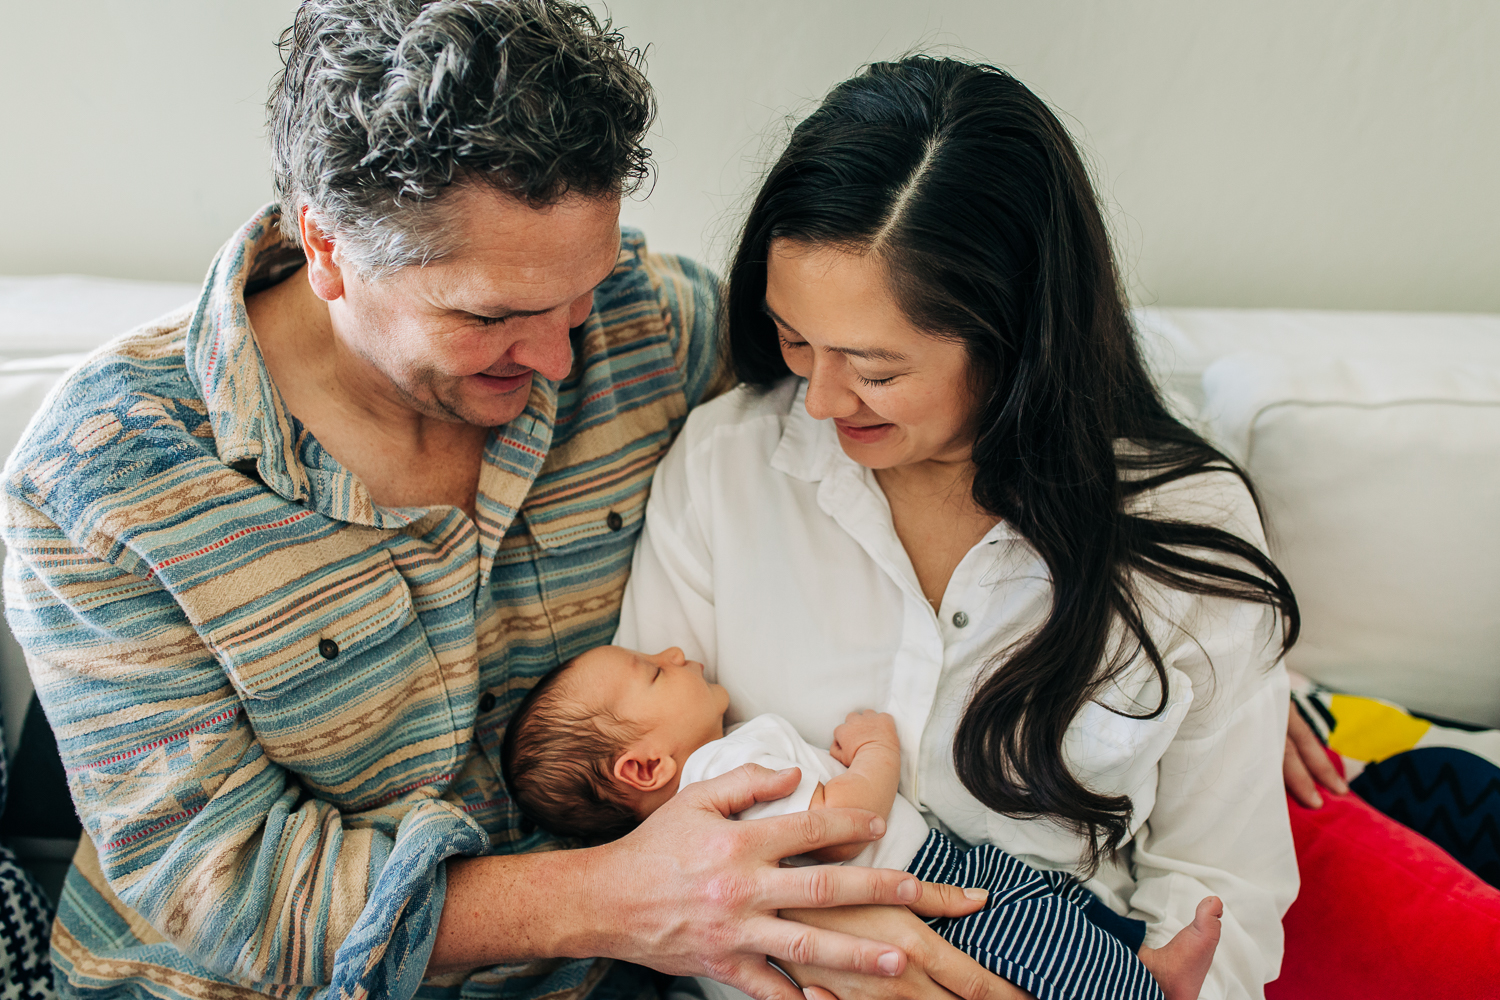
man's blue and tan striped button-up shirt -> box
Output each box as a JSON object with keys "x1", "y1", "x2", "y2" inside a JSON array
[{"x1": 3, "y1": 205, "x2": 722, "y2": 1000}]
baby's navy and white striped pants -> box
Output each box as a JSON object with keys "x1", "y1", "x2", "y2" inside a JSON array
[{"x1": 908, "y1": 831, "x2": 1163, "y2": 1000}]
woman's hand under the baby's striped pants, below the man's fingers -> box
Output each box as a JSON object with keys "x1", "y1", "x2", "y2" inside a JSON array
[{"x1": 777, "y1": 904, "x2": 1034, "y2": 1000}]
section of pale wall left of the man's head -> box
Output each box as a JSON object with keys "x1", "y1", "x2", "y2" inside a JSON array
[{"x1": 0, "y1": 0, "x2": 297, "y2": 282}]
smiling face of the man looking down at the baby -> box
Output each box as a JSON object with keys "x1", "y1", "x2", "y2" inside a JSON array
[{"x1": 329, "y1": 184, "x2": 620, "y2": 427}]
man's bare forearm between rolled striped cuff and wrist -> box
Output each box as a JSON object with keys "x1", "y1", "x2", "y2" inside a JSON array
[{"x1": 428, "y1": 849, "x2": 608, "y2": 976}]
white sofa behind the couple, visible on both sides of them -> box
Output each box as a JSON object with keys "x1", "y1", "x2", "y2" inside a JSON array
[{"x1": 0, "y1": 276, "x2": 1500, "y2": 893}]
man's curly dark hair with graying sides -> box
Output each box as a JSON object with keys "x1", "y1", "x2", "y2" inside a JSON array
[{"x1": 267, "y1": 0, "x2": 656, "y2": 277}]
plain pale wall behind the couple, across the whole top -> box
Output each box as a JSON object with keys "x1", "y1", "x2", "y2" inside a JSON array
[{"x1": 0, "y1": 0, "x2": 1500, "y2": 312}]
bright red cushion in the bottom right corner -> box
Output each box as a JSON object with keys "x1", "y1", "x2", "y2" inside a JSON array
[{"x1": 1266, "y1": 749, "x2": 1500, "y2": 1000}]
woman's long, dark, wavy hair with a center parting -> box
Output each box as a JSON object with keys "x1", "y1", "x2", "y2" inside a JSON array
[{"x1": 728, "y1": 57, "x2": 1299, "y2": 871}]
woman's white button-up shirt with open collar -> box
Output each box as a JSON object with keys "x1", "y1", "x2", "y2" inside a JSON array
[{"x1": 617, "y1": 379, "x2": 1298, "y2": 1000}]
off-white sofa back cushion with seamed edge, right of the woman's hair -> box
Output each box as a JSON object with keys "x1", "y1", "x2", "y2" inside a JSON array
[{"x1": 1203, "y1": 354, "x2": 1500, "y2": 727}]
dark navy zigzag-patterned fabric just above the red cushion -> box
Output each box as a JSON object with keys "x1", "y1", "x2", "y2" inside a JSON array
[{"x1": 1350, "y1": 747, "x2": 1500, "y2": 888}]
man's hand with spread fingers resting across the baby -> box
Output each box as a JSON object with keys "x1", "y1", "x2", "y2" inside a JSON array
[{"x1": 579, "y1": 765, "x2": 1005, "y2": 1000}]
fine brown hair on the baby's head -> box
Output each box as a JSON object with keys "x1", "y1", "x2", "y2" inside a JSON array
[{"x1": 500, "y1": 660, "x2": 641, "y2": 841}]
